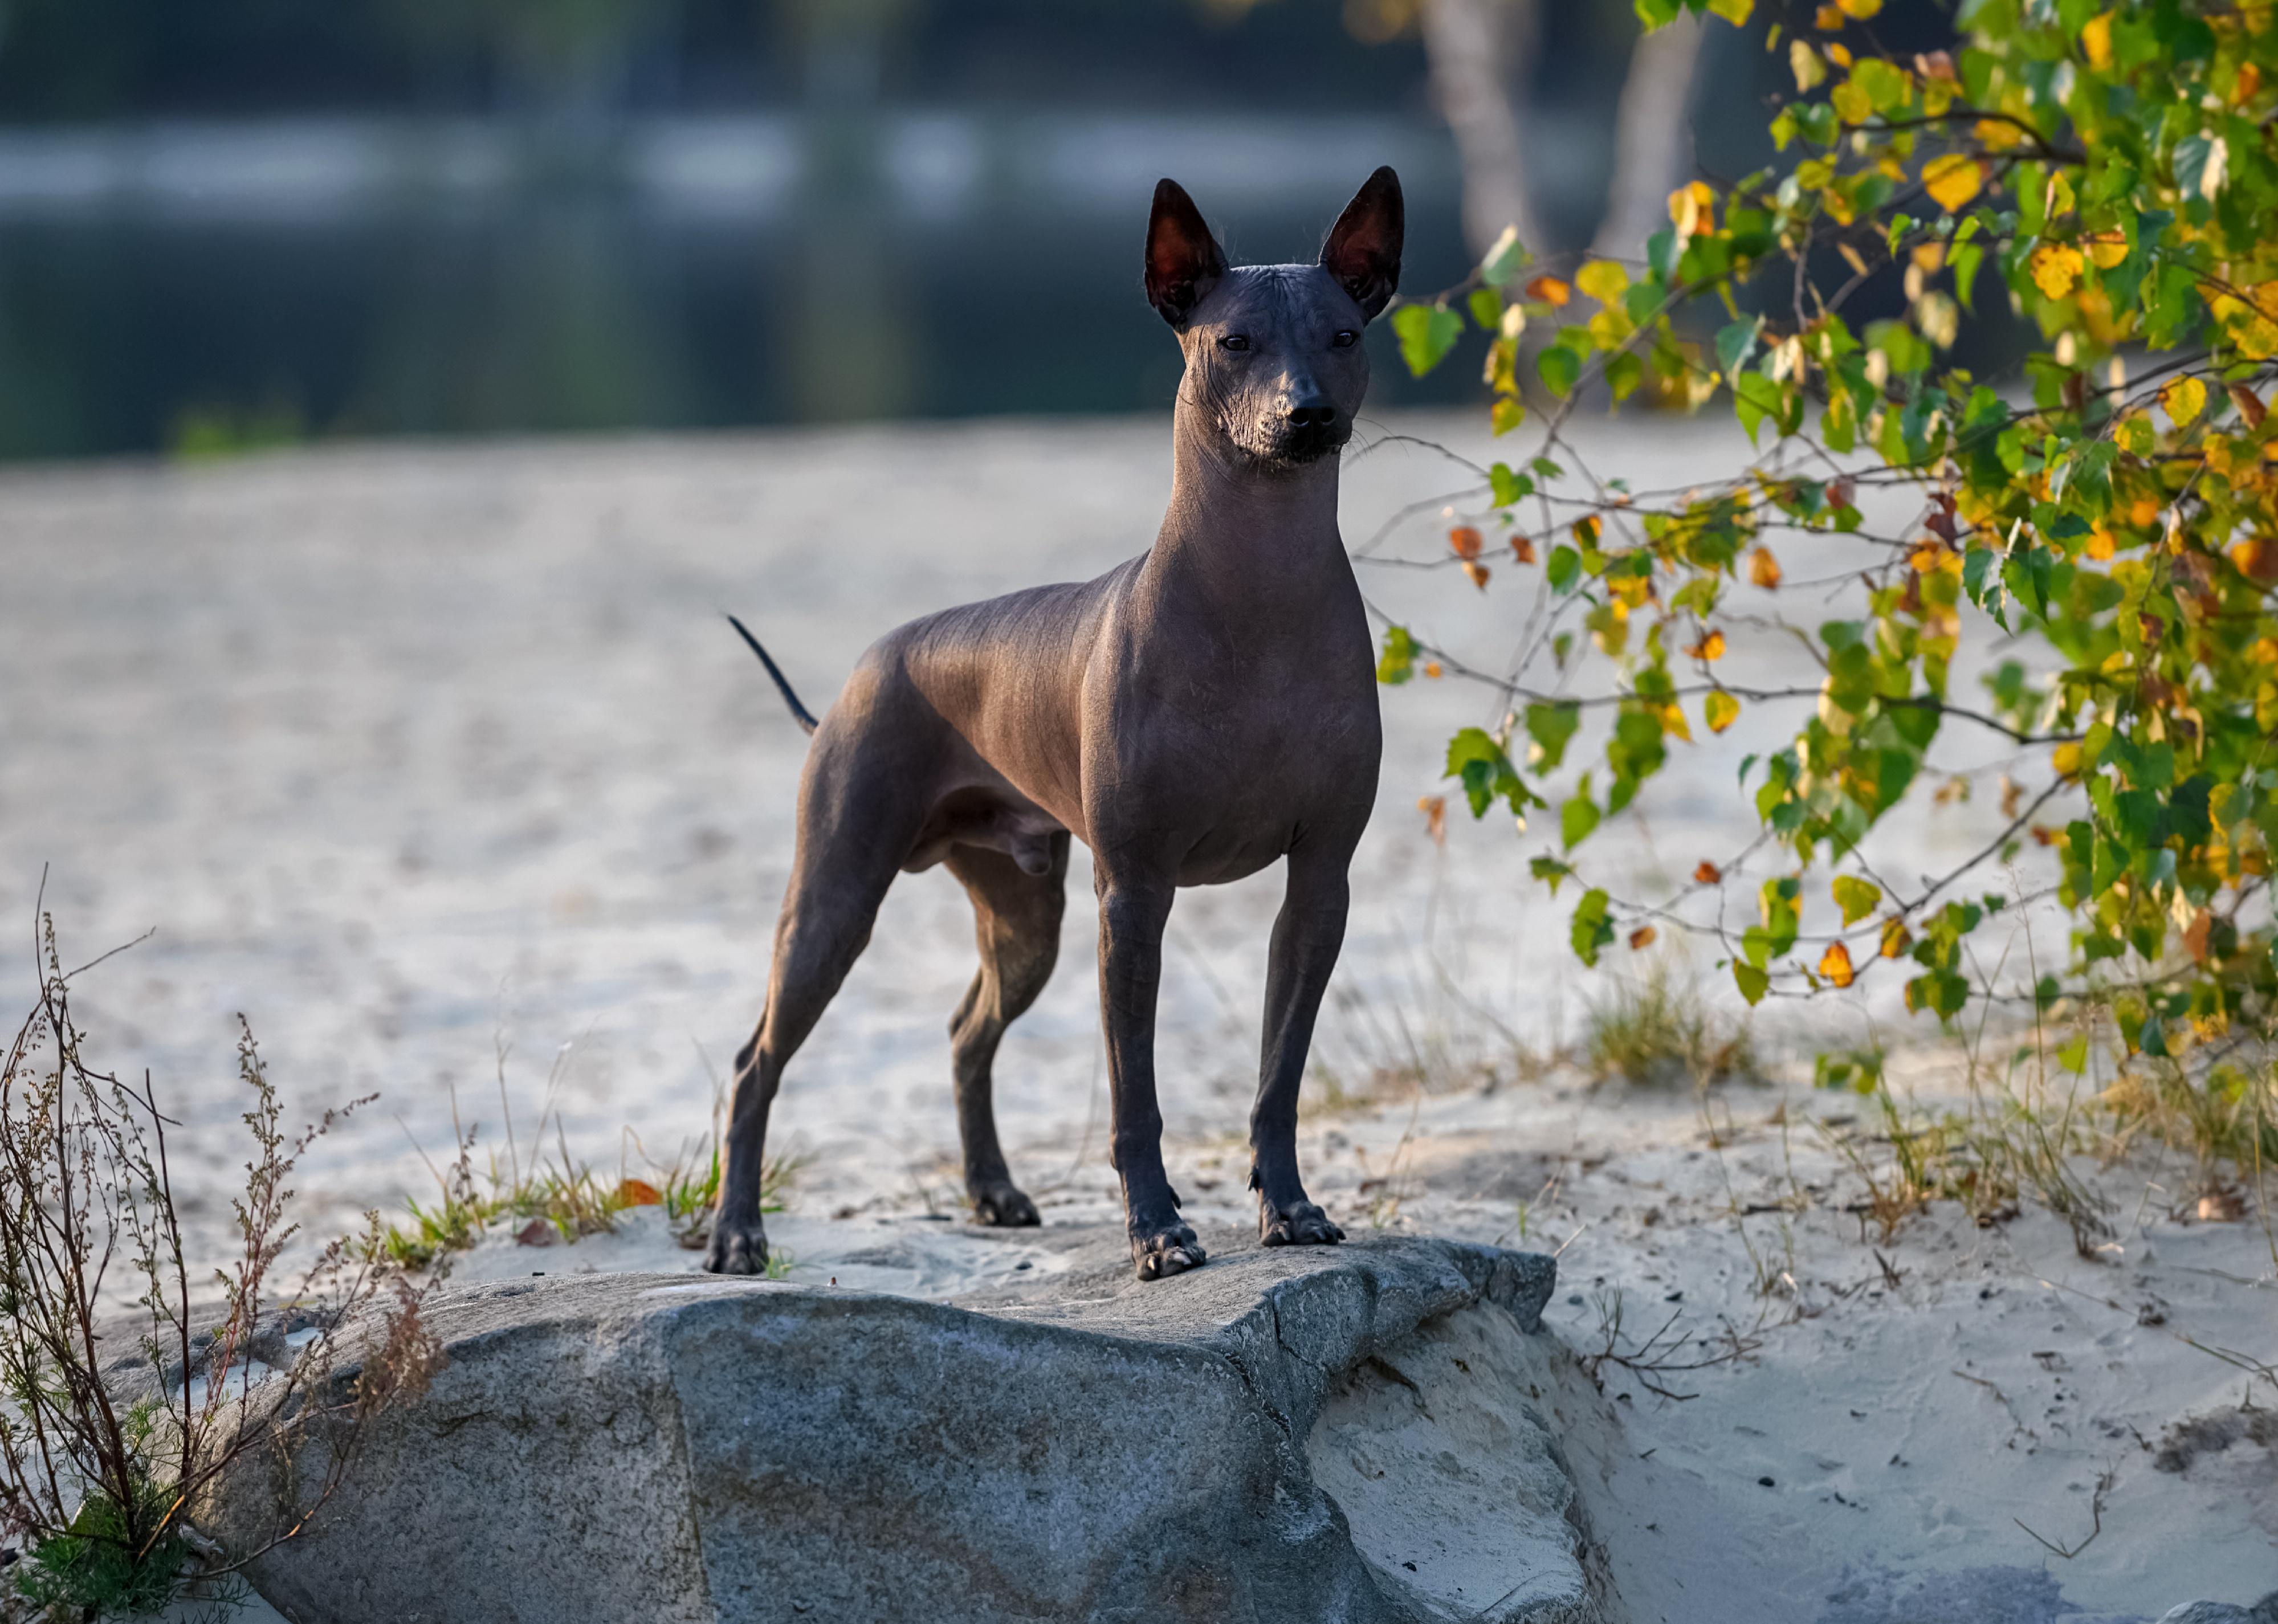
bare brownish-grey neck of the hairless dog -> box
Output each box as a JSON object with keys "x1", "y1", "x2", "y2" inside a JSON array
[{"x1": 1148, "y1": 399, "x2": 1353, "y2": 624}]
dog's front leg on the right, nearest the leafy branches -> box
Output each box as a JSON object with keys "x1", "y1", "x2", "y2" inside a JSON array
[{"x1": 1250, "y1": 852, "x2": 1348, "y2": 1246}]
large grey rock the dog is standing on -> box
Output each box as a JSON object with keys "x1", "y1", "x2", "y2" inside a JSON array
[{"x1": 221, "y1": 1230, "x2": 1601, "y2": 1624}]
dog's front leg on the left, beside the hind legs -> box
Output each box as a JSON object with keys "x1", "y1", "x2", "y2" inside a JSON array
[{"x1": 1098, "y1": 863, "x2": 1207, "y2": 1280}]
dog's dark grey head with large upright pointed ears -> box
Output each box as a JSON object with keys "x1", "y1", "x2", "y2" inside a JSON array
[{"x1": 1146, "y1": 169, "x2": 1403, "y2": 467}]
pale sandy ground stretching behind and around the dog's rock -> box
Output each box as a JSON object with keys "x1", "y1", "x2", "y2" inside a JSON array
[{"x1": 0, "y1": 421, "x2": 2278, "y2": 1624}]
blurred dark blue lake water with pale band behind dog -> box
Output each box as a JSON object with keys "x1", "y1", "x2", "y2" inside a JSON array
[{"x1": 0, "y1": 112, "x2": 1476, "y2": 458}]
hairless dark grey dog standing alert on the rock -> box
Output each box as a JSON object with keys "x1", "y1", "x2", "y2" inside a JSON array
[{"x1": 704, "y1": 169, "x2": 1401, "y2": 1280}]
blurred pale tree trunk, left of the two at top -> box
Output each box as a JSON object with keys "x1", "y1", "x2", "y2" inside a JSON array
[{"x1": 1421, "y1": 0, "x2": 1548, "y2": 255}]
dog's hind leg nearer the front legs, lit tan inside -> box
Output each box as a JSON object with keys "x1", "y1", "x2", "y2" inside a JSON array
[{"x1": 946, "y1": 831, "x2": 1069, "y2": 1225}]
